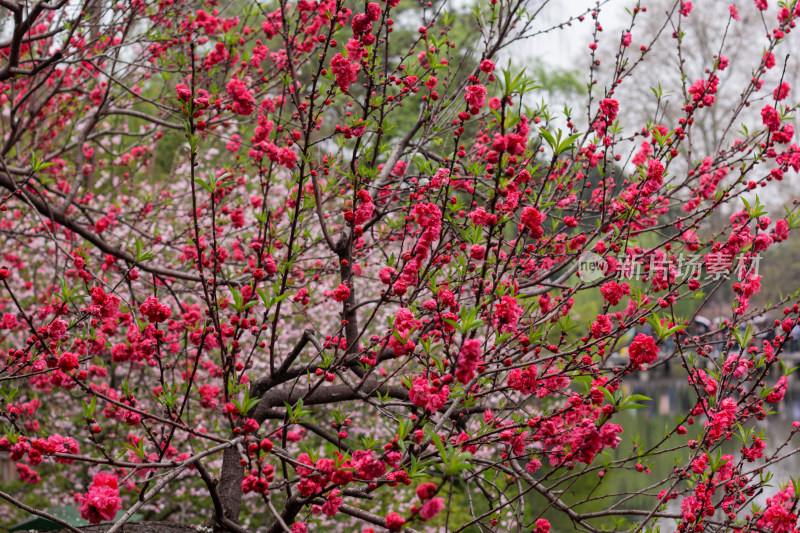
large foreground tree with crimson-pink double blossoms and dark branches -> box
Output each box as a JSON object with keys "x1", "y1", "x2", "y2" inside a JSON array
[{"x1": 0, "y1": 0, "x2": 800, "y2": 533}]
